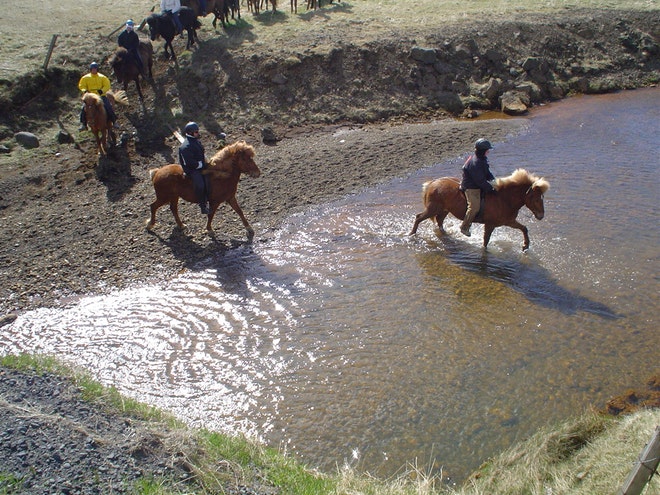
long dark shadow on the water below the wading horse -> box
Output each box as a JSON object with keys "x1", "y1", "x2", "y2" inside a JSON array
[{"x1": 418, "y1": 235, "x2": 623, "y2": 320}]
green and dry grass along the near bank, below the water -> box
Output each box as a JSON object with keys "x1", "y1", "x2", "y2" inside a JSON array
[{"x1": 0, "y1": 355, "x2": 660, "y2": 495}]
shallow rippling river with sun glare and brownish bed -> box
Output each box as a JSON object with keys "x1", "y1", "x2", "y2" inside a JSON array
[{"x1": 0, "y1": 89, "x2": 660, "y2": 481}]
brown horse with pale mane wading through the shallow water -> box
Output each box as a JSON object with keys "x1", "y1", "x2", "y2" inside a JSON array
[{"x1": 410, "y1": 168, "x2": 550, "y2": 251}]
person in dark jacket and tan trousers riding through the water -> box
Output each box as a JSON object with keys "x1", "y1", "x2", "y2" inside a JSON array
[{"x1": 460, "y1": 138, "x2": 495, "y2": 237}]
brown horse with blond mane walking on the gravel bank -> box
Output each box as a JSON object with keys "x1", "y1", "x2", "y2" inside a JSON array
[{"x1": 147, "y1": 141, "x2": 261, "y2": 237}]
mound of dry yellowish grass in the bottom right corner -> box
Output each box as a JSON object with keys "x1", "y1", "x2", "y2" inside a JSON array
[{"x1": 459, "y1": 409, "x2": 660, "y2": 495}]
